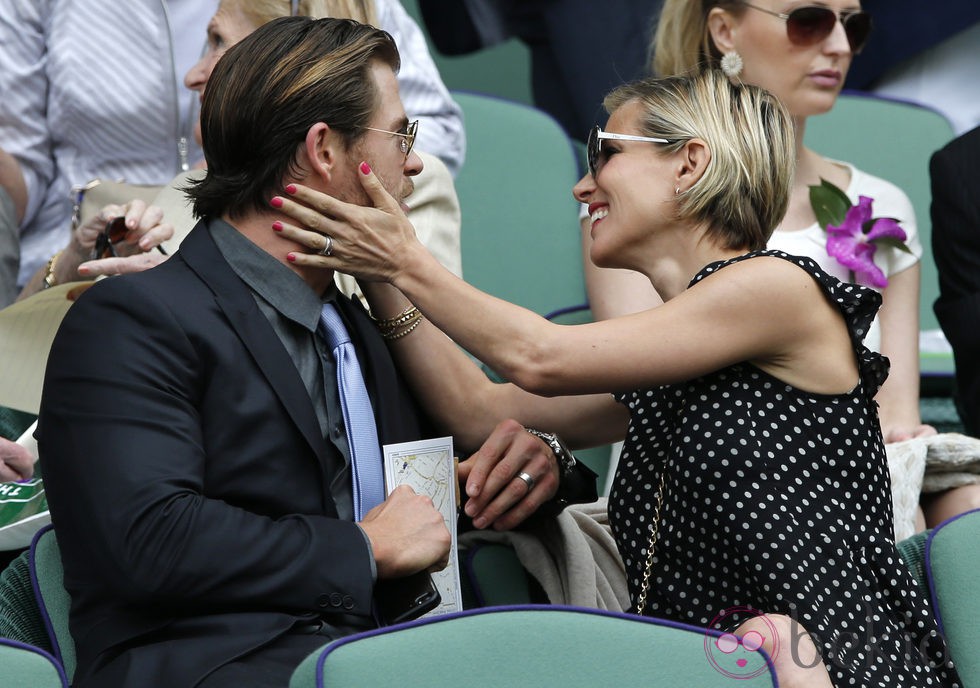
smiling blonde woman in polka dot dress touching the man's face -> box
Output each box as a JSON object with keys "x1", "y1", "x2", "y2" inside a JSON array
[{"x1": 281, "y1": 70, "x2": 957, "y2": 687}]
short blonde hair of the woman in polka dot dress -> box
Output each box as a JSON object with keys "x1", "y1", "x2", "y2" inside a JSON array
[{"x1": 604, "y1": 69, "x2": 796, "y2": 251}]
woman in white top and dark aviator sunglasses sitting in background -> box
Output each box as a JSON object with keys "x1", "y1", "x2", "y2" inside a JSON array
[{"x1": 583, "y1": 0, "x2": 977, "y2": 527}]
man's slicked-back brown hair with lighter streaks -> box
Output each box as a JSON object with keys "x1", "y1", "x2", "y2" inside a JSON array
[{"x1": 187, "y1": 17, "x2": 400, "y2": 218}]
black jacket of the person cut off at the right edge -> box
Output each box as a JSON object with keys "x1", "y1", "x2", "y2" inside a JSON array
[{"x1": 929, "y1": 128, "x2": 980, "y2": 436}]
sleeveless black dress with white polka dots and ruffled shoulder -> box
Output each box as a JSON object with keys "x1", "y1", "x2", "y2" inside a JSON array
[{"x1": 609, "y1": 251, "x2": 958, "y2": 687}]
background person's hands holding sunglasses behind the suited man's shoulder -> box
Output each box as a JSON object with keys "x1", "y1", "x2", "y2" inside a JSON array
[{"x1": 17, "y1": 200, "x2": 174, "y2": 301}]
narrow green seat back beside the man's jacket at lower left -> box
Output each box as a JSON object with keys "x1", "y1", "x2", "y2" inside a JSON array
[{"x1": 30, "y1": 527, "x2": 75, "y2": 681}]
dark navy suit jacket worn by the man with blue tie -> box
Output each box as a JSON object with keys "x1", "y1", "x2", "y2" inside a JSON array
[{"x1": 38, "y1": 226, "x2": 421, "y2": 688}]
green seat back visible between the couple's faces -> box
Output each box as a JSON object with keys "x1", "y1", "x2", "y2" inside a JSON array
[{"x1": 453, "y1": 92, "x2": 586, "y2": 315}]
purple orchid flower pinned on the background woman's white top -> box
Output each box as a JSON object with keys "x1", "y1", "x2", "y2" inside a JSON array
[{"x1": 827, "y1": 196, "x2": 907, "y2": 289}]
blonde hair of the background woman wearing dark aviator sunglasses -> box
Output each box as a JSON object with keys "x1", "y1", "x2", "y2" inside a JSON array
[{"x1": 650, "y1": 0, "x2": 745, "y2": 76}]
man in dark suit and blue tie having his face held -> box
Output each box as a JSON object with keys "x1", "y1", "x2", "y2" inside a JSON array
[{"x1": 37, "y1": 18, "x2": 588, "y2": 688}]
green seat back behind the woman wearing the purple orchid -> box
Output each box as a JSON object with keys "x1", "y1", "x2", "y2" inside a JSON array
[{"x1": 805, "y1": 93, "x2": 954, "y2": 372}]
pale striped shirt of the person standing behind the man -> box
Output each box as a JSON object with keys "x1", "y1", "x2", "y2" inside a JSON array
[{"x1": 0, "y1": 0, "x2": 465, "y2": 286}]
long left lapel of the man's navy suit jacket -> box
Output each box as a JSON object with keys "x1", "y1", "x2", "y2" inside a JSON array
[{"x1": 179, "y1": 222, "x2": 327, "y2": 463}]
